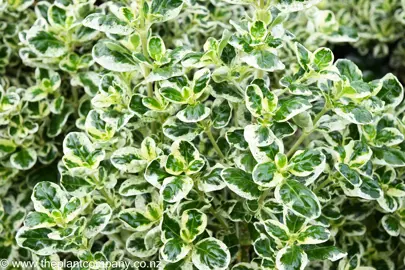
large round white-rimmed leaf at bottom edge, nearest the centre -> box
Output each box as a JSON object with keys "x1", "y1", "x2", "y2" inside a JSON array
[{"x1": 191, "y1": 237, "x2": 231, "y2": 270}]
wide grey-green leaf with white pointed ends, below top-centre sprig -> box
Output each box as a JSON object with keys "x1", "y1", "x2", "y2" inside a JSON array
[{"x1": 241, "y1": 50, "x2": 285, "y2": 72}]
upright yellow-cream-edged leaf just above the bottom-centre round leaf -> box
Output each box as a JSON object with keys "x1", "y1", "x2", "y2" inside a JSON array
[{"x1": 180, "y1": 209, "x2": 207, "y2": 243}]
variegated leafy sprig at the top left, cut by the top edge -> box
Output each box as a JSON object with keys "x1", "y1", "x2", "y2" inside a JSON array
[{"x1": 19, "y1": 1, "x2": 99, "y2": 69}]
